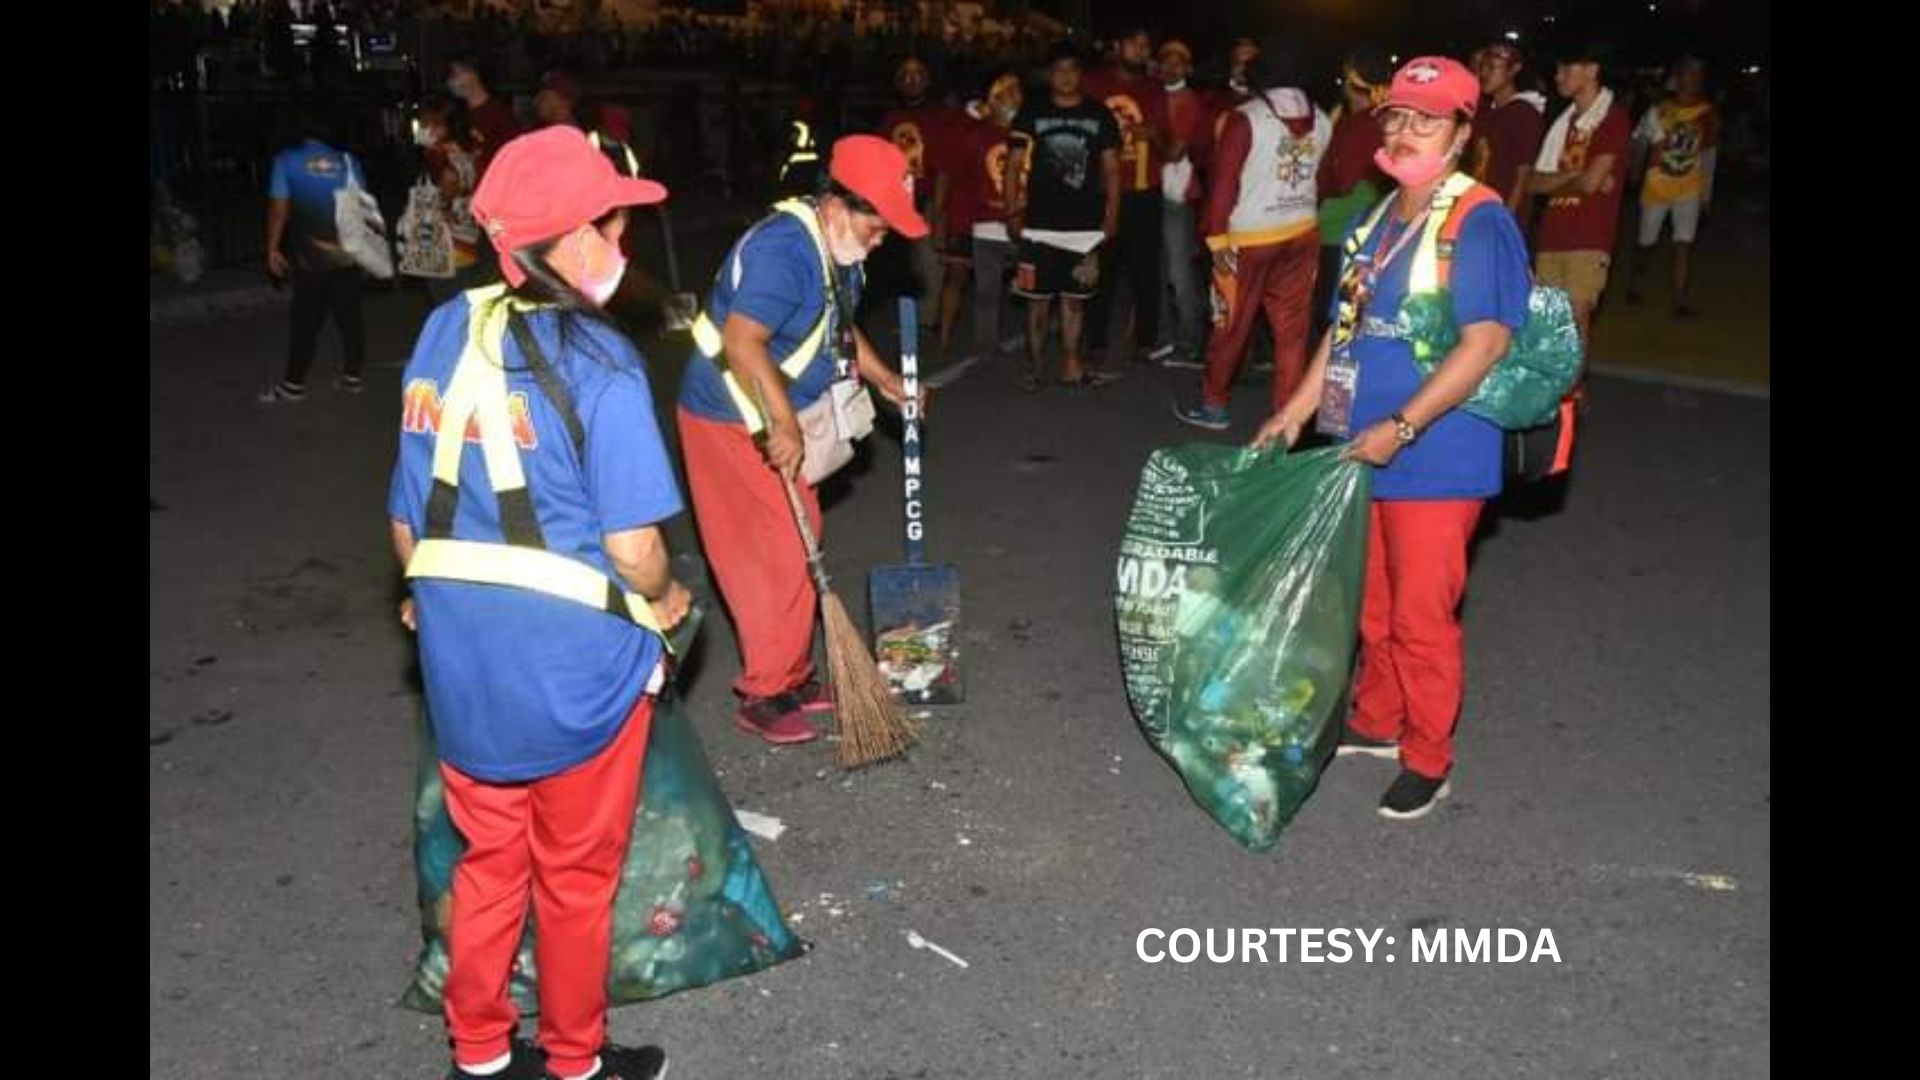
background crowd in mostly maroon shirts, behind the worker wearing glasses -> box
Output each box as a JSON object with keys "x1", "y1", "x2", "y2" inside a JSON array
[{"x1": 837, "y1": 29, "x2": 1722, "y2": 409}]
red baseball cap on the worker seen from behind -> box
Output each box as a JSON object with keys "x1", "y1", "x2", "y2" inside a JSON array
[{"x1": 474, "y1": 125, "x2": 666, "y2": 286}]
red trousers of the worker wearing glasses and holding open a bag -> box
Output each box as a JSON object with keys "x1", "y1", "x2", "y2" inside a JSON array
[{"x1": 1348, "y1": 500, "x2": 1480, "y2": 778}]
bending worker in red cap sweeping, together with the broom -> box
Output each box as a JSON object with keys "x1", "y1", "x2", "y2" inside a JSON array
[{"x1": 678, "y1": 135, "x2": 927, "y2": 765}]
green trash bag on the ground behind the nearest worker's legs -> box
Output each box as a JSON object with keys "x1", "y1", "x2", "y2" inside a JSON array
[{"x1": 401, "y1": 634, "x2": 804, "y2": 1017}]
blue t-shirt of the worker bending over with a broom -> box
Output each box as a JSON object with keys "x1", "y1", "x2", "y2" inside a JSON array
[{"x1": 680, "y1": 211, "x2": 860, "y2": 423}]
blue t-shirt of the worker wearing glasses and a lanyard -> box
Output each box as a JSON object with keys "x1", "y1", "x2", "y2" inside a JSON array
[{"x1": 1334, "y1": 202, "x2": 1532, "y2": 500}]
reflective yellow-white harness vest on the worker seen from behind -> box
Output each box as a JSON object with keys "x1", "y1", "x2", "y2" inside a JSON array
[{"x1": 407, "y1": 284, "x2": 672, "y2": 651}]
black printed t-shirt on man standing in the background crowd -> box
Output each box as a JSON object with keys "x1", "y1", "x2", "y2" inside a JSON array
[{"x1": 1012, "y1": 96, "x2": 1119, "y2": 233}]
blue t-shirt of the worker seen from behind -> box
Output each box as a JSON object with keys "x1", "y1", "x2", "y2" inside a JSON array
[{"x1": 388, "y1": 296, "x2": 682, "y2": 782}]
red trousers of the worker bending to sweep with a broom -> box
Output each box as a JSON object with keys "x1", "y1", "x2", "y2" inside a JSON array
[{"x1": 680, "y1": 409, "x2": 822, "y2": 698}]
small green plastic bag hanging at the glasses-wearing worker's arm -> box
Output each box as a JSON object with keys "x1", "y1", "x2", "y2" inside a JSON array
[{"x1": 1400, "y1": 284, "x2": 1580, "y2": 430}]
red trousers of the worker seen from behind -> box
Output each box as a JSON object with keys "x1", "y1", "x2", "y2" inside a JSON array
[{"x1": 440, "y1": 694, "x2": 653, "y2": 1076}]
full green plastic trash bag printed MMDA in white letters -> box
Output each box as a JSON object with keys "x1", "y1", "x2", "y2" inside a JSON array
[{"x1": 1114, "y1": 444, "x2": 1371, "y2": 851}]
